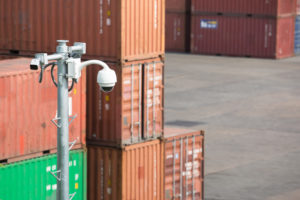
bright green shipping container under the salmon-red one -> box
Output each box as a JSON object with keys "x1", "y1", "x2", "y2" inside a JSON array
[{"x1": 0, "y1": 150, "x2": 87, "y2": 200}]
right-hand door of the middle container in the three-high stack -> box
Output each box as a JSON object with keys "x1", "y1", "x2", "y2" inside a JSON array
[{"x1": 143, "y1": 62, "x2": 164, "y2": 139}]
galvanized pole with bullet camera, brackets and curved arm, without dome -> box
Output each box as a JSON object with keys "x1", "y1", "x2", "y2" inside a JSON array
[{"x1": 30, "y1": 40, "x2": 116, "y2": 200}]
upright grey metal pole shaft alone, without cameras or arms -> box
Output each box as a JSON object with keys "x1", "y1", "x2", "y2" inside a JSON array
[{"x1": 56, "y1": 40, "x2": 69, "y2": 200}]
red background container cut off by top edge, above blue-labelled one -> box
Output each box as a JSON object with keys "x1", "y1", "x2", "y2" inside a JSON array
[{"x1": 191, "y1": 0, "x2": 297, "y2": 16}]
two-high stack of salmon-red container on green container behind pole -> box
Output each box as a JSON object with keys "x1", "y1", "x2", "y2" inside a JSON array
[{"x1": 0, "y1": 56, "x2": 87, "y2": 200}]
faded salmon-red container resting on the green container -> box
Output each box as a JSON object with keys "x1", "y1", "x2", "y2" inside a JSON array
[{"x1": 0, "y1": 58, "x2": 86, "y2": 160}]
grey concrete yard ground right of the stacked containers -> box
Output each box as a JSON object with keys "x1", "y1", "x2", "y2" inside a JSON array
[{"x1": 165, "y1": 53, "x2": 300, "y2": 200}]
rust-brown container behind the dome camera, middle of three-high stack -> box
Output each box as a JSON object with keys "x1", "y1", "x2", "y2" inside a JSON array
[{"x1": 87, "y1": 58, "x2": 164, "y2": 146}]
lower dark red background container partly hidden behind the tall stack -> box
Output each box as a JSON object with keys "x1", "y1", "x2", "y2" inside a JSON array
[{"x1": 165, "y1": 12, "x2": 189, "y2": 52}]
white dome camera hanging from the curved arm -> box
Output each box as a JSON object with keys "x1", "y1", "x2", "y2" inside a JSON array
[{"x1": 97, "y1": 68, "x2": 117, "y2": 92}]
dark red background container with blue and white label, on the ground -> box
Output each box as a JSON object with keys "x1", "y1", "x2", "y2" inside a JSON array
[{"x1": 191, "y1": 15, "x2": 295, "y2": 58}]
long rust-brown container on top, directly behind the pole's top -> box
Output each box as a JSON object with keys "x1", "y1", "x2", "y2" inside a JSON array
[{"x1": 0, "y1": 0, "x2": 165, "y2": 60}]
